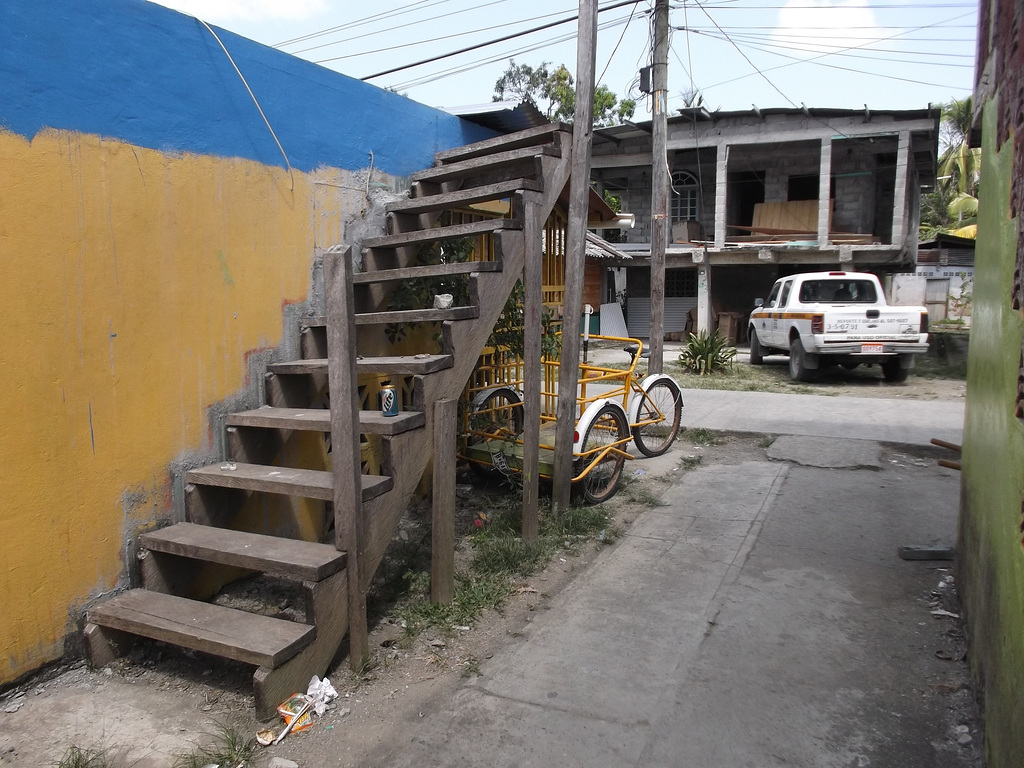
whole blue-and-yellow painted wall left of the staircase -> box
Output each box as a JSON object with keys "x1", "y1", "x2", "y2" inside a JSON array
[{"x1": 0, "y1": 0, "x2": 494, "y2": 684}]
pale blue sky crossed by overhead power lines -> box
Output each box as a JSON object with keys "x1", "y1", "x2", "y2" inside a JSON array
[{"x1": 149, "y1": 0, "x2": 978, "y2": 121}]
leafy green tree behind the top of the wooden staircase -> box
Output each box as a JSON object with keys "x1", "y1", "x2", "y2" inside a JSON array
[{"x1": 494, "y1": 59, "x2": 636, "y2": 128}]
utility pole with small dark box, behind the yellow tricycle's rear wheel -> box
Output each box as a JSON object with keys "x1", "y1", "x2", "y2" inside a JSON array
[{"x1": 647, "y1": 0, "x2": 672, "y2": 374}]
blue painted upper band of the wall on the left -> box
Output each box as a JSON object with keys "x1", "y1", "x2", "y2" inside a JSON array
[{"x1": 0, "y1": 0, "x2": 494, "y2": 176}]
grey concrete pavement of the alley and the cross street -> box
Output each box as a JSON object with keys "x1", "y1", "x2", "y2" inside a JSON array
[{"x1": 360, "y1": 390, "x2": 980, "y2": 768}]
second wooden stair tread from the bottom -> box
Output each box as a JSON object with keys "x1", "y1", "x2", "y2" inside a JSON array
[{"x1": 139, "y1": 522, "x2": 346, "y2": 582}]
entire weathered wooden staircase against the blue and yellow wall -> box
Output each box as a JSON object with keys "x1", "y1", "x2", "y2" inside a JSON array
[{"x1": 85, "y1": 125, "x2": 571, "y2": 718}]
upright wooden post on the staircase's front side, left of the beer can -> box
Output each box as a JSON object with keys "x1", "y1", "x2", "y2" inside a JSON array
[{"x1": 324, "y1": 248, "x2": 370, "y2": 670}]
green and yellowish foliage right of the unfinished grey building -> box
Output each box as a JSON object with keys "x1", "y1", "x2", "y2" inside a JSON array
[{"x1": 921, "y1": 96, "x2": 981, "y2": 240}]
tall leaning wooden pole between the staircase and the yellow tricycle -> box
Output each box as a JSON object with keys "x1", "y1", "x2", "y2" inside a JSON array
[{"x1": 551, "y1": 0, "x2": 597, "y2": 512}]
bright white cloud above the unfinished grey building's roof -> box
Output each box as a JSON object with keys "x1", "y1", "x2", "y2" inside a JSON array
[{"x1": 773, "y1": 0, "x2": 891, "y2": 57}]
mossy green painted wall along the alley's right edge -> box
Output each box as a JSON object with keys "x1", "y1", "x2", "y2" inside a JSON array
[{"x1": 957, "y1": 99, "x2": 1024, "y2": 768}]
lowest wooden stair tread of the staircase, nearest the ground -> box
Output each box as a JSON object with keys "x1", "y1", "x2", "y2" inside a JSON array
[{"x1": 88, "y1": 590, "x2": 316, "y2": 668}]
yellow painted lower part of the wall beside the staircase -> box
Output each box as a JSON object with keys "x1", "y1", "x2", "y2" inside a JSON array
[{"x1": 0, "y1": 130, "x2": 365, "y2": 683}]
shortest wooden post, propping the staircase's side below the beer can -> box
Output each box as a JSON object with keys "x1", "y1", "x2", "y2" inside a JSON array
[{"x1": 430, "y1": 398, "x2": 459, "y2": 605}]
